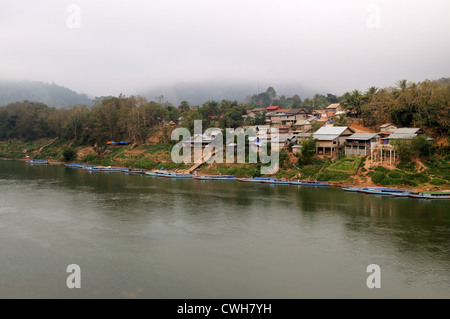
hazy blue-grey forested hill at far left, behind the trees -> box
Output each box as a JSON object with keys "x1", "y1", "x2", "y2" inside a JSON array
[{"x1": 0, "y1": 81, "x2": 92, "y2": 108}]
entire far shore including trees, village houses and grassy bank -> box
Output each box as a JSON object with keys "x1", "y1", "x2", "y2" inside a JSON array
[{"x1": 0, "y1": 79, "x2": 450, "y2": 195}]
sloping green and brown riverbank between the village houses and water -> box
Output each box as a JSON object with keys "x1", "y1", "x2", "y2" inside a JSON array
[{"x1": 0, "y1": 139, "x2": 450, "y2": 191}]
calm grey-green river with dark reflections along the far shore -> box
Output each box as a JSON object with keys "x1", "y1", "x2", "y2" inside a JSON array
[{"x1": 0, "y1": 161, "x2": 450, "y2": 299}]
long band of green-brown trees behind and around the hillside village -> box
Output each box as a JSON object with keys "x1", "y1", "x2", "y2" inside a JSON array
[{"x1": 0, "y1": 79, "x2": 450, "y2": 145}]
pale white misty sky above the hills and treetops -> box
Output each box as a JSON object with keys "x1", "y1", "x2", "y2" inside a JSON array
[{"x1": 0, "y1": 0, "x2": 450, "y2": 96}]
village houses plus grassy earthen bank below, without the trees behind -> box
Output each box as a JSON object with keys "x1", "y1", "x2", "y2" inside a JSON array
[{"x1": 0, "y1": 103, "x2": 449, "y2": 196}]
